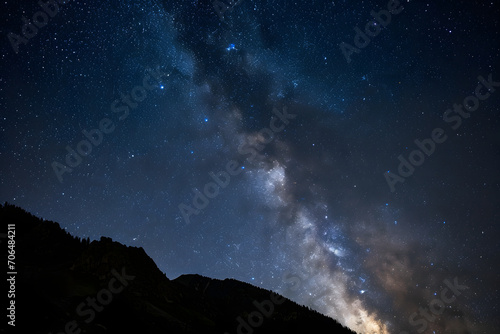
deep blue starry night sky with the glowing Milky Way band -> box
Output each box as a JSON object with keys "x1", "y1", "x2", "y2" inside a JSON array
[{"x1": 0, "y1": 0, "x2": 500, "y2": 334}]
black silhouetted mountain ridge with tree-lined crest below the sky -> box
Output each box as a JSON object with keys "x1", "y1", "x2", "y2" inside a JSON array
[{"x1": 0, "y1": 204, "x2": 354, "y2": 334}]
